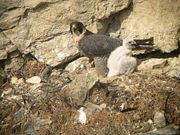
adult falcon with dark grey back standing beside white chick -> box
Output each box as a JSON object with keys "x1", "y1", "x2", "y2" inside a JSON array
[{"x1": 70, "y1": 21, "x2": 153, "y2": 77}]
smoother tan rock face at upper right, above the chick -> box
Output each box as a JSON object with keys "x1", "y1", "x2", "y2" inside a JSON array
[{"x1": 107, "y1": 0, "x2": 180, "y2": 52}]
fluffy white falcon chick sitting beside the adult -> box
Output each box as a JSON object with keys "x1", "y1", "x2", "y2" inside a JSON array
[{"x1": 107, "y1": 39, "x2": 137, "y2": 77}]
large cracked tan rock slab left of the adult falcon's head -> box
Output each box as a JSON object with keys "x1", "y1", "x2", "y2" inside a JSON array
[{"x1": 0, "y1": 0, "x2": 130, "y2": 66}]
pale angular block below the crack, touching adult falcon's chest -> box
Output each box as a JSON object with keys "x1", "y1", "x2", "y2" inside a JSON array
[{"x1": 30, "y1": 35, "x2": 77, "y2": 66}]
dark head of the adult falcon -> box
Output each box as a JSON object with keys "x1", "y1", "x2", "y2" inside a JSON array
[{"x1": 70, "y1": 21, "x2": 86, "y2": 36}]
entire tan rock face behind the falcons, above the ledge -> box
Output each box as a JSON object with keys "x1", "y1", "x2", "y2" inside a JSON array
[{"x1": 0, "y1": 0, "x2": 180, "y2": 66}]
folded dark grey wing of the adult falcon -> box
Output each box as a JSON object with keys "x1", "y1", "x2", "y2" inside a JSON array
[{"x1": 78, "y1": 34, "x2": 122, "y2": 57}]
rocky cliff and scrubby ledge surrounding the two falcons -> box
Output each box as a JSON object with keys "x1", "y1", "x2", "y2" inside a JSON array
[{"x1": 0, "y1": 0, "x2": 180, "y2": 135}]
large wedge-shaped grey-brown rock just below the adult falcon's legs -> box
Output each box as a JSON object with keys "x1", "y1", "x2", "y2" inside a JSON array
[{"x1": 64, "y1": 69, "x2": 98, "y2": 106}]
